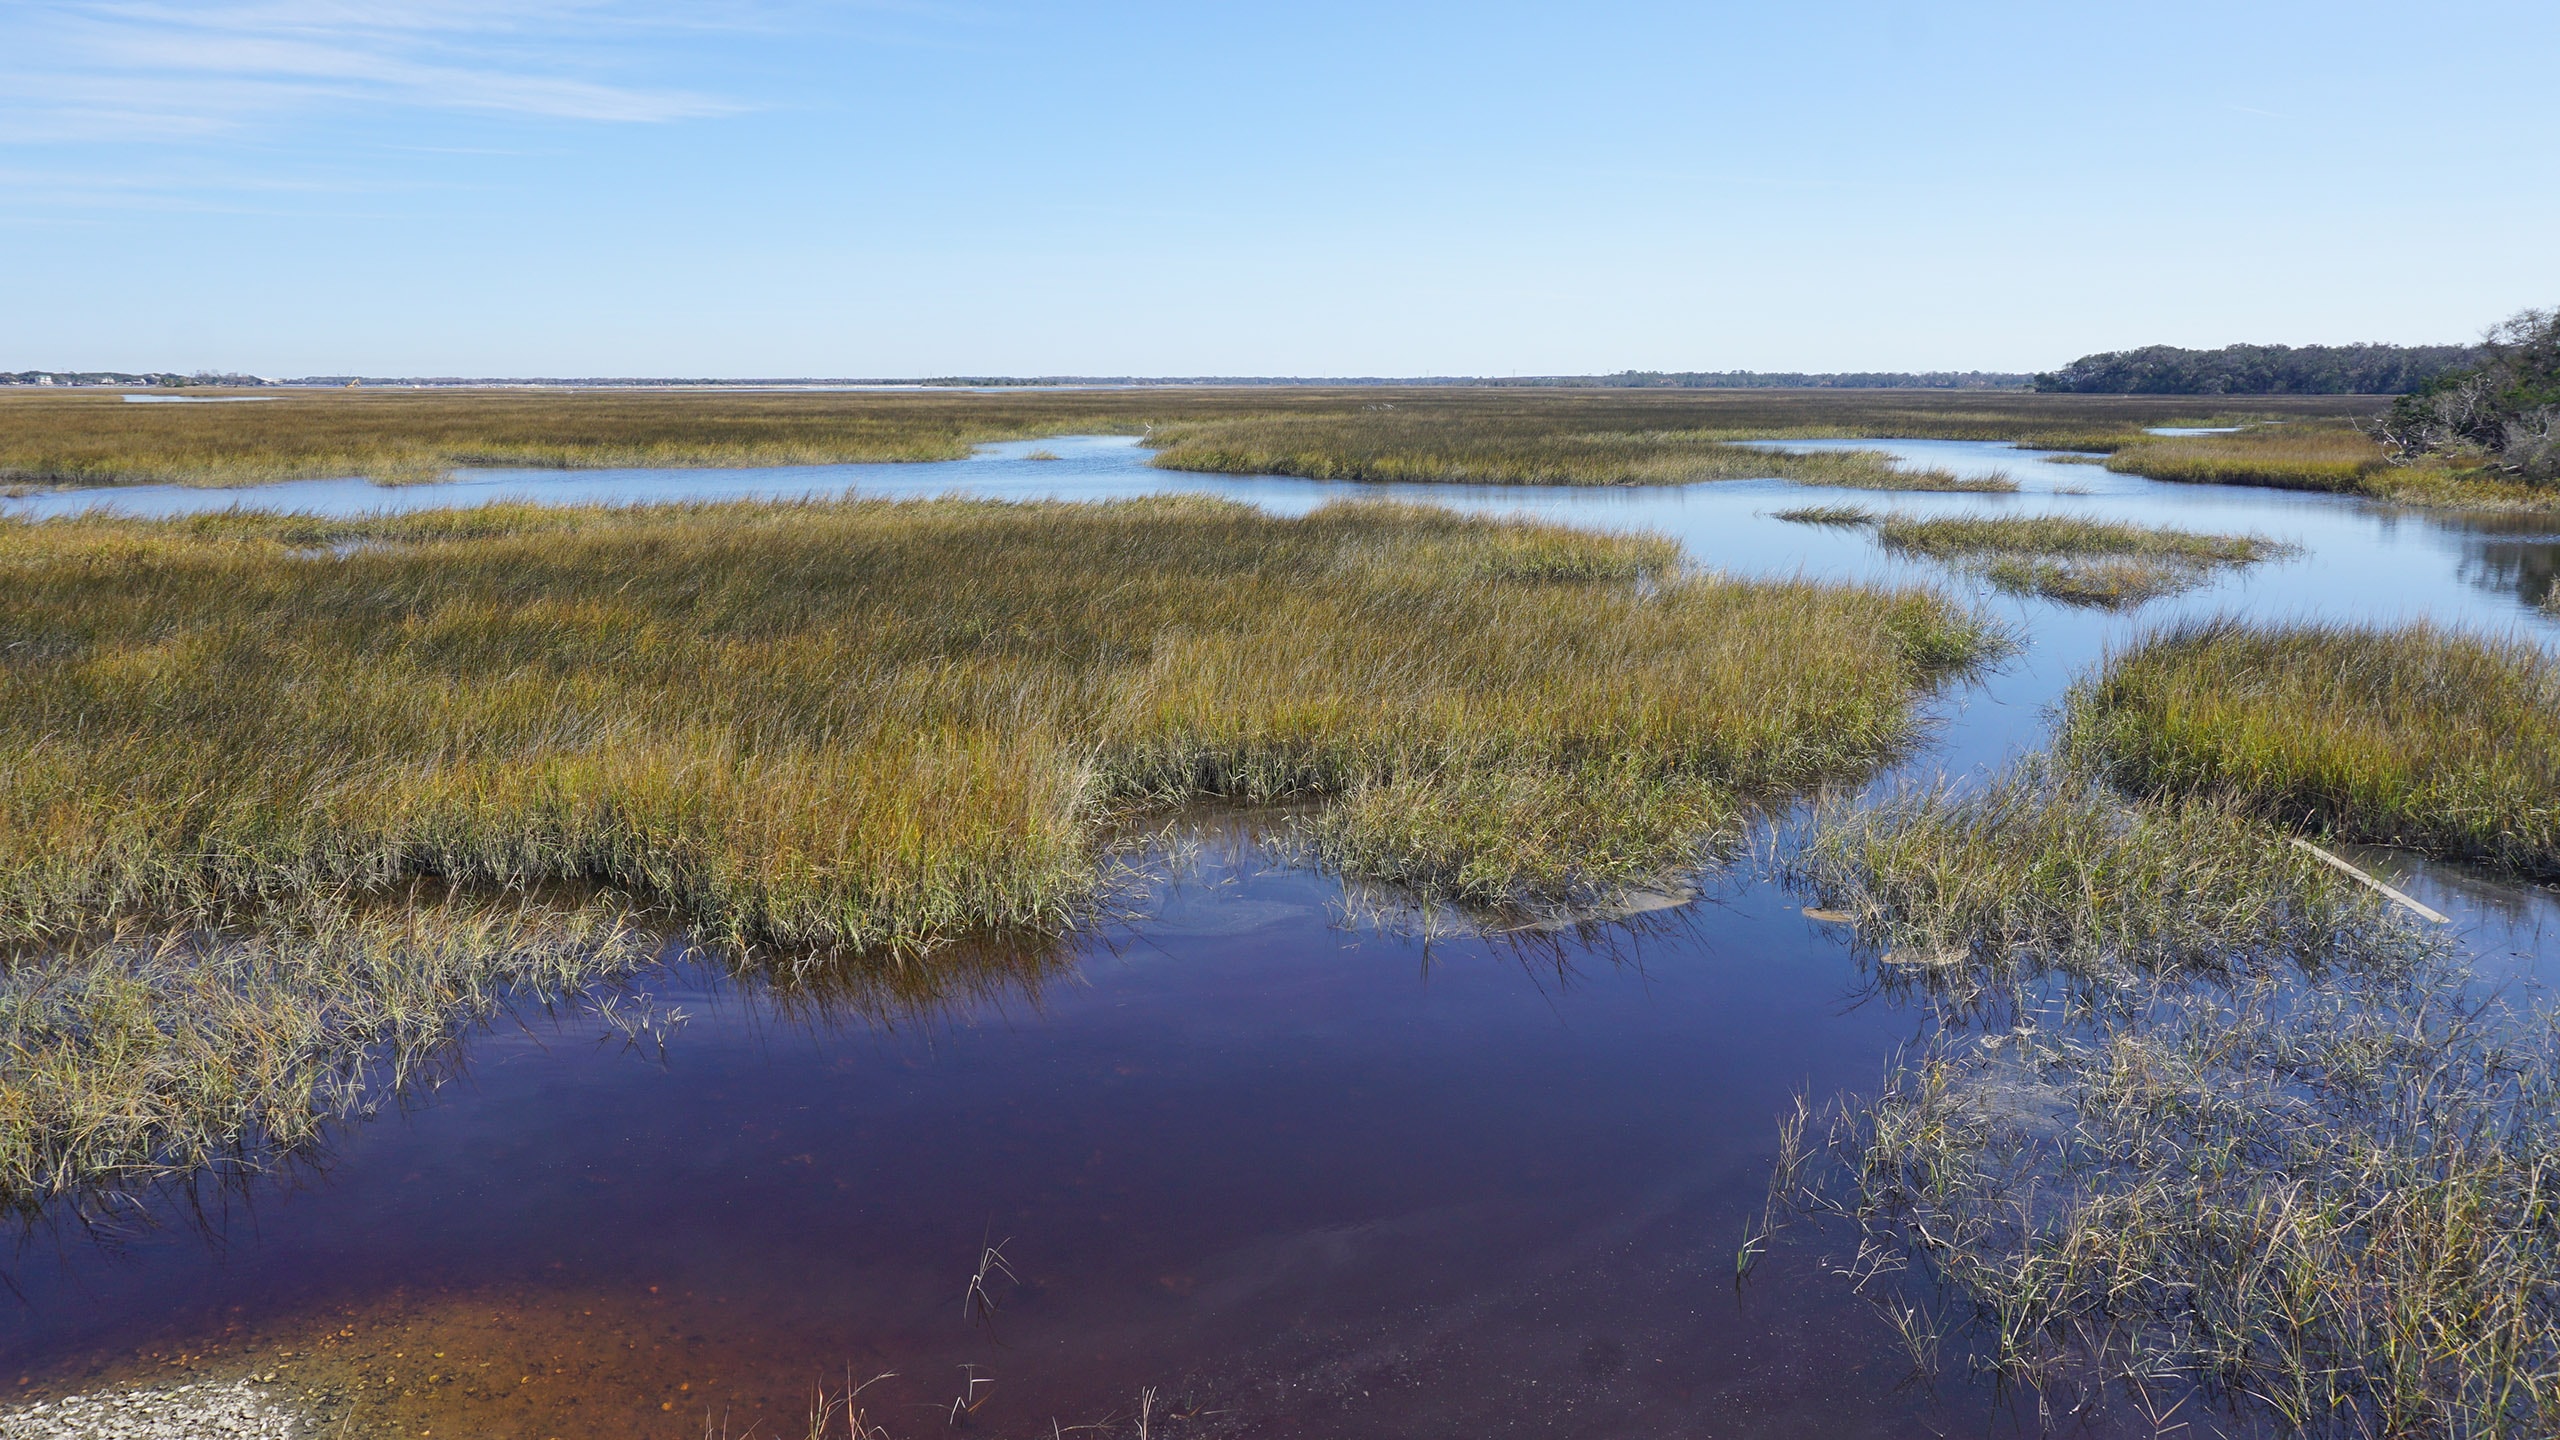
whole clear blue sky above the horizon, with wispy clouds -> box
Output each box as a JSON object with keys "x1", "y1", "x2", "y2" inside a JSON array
[{"x1": 0, "y1": 0, "x2": 2560, "y2": 377}]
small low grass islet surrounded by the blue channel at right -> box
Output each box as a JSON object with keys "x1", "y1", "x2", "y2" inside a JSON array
[{"x1": 1876, "y1": 515, "x2": 2294, "y2": 610}]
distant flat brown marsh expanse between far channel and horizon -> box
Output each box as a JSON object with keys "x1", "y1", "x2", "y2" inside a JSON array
[{"x1": 0, "y1": 387, "x2": 2378, "y2": 487}]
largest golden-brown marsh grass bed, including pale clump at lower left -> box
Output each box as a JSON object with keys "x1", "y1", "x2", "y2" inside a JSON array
[{"x1": 0, "y1": 497, "x2": 1999, "y2": 1204}]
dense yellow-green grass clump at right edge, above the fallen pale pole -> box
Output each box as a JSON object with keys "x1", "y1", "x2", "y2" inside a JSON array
[{"x1": 2063, "y1": 618, "x2": 2560, "y2": 876}]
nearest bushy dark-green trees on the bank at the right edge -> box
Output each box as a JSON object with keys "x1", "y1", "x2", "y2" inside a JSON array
[{"x1": 2373, "y1": 310, "x2": 2560, "y2": 484}]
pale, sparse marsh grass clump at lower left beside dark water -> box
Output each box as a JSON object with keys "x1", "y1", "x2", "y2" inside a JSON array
[{"x1": 0, "y1": 894, "x2": 653, "y2": 1209}]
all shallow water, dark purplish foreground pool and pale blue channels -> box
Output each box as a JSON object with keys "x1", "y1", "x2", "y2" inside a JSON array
[{"x1": 0, "y1": 438, "x2": 2560, "y2": 1440}]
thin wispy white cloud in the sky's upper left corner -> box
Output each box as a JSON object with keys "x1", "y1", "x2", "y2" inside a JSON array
[{"x1": 0, "y1": 0, "x2": 742, "y2": 143}]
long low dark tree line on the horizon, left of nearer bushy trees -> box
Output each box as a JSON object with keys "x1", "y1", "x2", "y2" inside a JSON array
[{"x1": 2035, "y1": 346, "x2": 2481, "y2": 395}]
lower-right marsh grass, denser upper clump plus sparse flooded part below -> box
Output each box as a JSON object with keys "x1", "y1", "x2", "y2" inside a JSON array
[{"x1": 1779, "y1": 758, "x2": 2560, "y2": 1435}]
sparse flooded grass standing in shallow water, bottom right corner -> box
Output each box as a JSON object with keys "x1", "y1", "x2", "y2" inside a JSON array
[{"x1": 1828, "y1": 966, "x2": 2560, "y2": 1435}]
